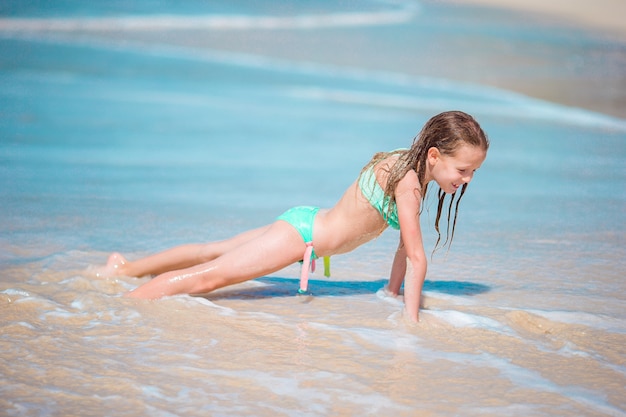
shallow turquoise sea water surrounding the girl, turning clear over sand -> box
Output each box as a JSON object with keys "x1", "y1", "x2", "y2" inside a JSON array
[{"x1": 0, "y1": 1, "x2": 626, "y2": 416}]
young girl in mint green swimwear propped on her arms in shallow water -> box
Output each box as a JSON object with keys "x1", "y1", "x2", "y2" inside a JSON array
[{"x1": 103, "y1": 111, "x2": 489, "y2": 321}]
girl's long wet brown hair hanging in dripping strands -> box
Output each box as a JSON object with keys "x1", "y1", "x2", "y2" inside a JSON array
[{"x1": 361, "y1": 111, "x2": 489, "y2": 252}]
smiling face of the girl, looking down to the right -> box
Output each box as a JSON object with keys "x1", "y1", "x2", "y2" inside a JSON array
[{"x1": 428, "y1": 144, "x2": 487, "y2": 194}]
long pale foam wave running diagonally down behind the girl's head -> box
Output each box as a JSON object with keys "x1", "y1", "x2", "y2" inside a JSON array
[{"x1": 7, "y1": 27, "x2": 626, "y2": 132}]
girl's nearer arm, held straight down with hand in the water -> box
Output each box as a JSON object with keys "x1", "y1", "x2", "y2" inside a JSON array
[{"x1": 394, "y1": 171, "x2": 426, "y2": 321}]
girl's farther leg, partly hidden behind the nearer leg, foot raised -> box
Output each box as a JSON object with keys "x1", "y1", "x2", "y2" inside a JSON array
[{"x1": 104, "y1": 226, "x2": 269, "y2": 277}]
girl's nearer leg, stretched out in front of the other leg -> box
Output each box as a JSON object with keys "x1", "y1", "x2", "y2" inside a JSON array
[{"x1": 127, "y1": 221, "x2": 306, "y2": 299}]
